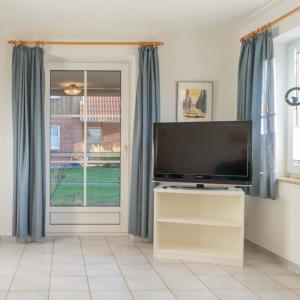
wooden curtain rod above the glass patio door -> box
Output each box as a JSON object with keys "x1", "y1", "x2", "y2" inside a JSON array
[{"x1": 8, "y1": 40, "x2": 164, "y2": 47}]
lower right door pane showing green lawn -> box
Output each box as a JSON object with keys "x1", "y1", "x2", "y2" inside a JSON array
[{"x1": 87, "y1": 161, "x2": 120, "y2": 206}]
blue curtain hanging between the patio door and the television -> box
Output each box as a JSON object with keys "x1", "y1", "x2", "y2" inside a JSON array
[{"x1": 129, "y1": 47, "x2": 160, "y2": 239}]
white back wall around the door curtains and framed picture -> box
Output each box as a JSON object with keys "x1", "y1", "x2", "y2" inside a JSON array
[{"x1": 0, "y1": 32, "x2": 239, "y2": 236}]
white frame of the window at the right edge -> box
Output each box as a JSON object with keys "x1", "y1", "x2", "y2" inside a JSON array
[{"x1": 286, "y1": 39, "x2": 300, "y2": 177}]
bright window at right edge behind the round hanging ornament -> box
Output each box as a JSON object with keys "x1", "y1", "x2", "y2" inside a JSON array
[{"x1": 287, "y1": 42, "x2": 300, "y2": 174}]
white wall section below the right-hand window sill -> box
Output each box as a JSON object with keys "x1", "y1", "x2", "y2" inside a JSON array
[{"x1": 246, "y1": 183, "x2": 300, "y2": 265}]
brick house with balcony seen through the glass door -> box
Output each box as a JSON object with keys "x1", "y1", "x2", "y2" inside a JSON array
[{"x1": 50, "y1": 96, "x2": 121, "y2": 153}]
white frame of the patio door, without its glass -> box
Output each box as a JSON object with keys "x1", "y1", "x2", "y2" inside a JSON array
[{"x1": 45, "y1": 62, "x2": 131, "y2": 235}]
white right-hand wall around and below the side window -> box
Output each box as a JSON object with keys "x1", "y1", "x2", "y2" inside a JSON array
[{"x1": 241, "y1": 0, "x2": 300, "y2": 265}]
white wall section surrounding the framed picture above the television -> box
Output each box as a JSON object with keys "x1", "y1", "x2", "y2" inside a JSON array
[{"x1": 160, "y1": 32, "x2": 239, "y2": 121}]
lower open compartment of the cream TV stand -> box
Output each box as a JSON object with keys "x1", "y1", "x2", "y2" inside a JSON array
[{"x1": 156, "y1": 222, "x2": 243, "y2": 261}]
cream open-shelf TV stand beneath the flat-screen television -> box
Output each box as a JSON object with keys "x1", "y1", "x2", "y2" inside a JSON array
[{"x1": 154, "y1": 186, "x2": 245, "y2": 266}]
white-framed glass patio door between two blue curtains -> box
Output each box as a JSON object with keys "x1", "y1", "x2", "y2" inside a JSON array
[{"x1": 46, "y1": 65, "x2": 128, "y2": 233}]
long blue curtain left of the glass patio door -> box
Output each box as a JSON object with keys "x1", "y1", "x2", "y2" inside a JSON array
[{"x1": 12, "y1": 46, "x2": 45, "y2": 240}]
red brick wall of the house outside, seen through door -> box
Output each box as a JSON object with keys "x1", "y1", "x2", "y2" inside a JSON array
[{"x1": 51, "y1": 117, "x2": 121, "y2": 152}]
